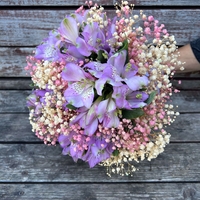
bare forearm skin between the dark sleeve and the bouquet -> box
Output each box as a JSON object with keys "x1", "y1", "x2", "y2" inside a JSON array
[{"x1": 176, "y1": 44, "x2": 200, "y2": 73}]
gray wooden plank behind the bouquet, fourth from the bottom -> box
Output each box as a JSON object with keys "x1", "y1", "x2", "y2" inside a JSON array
[{"x1": 0, "y1": 90, "x2": 200, "y2": 113}]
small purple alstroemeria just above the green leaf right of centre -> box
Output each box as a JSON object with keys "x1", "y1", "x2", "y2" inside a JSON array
[{"x1": 112, "y1": 85, "x2": 149, "y2": 109}]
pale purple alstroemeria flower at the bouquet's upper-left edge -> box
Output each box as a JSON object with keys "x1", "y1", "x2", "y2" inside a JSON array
[{"x1": 35, "y1": 31, "x2": 65, "y2": 61}]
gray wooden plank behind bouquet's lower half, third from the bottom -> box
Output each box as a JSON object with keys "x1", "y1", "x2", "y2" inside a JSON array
[{"x1": 0, "y1": 114, "x2": 200, "y2": 143}]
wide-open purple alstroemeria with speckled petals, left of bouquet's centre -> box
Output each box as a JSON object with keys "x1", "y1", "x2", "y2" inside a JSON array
[{"x1": 61, "y1": 63, "x2": 94, "y2": 108}]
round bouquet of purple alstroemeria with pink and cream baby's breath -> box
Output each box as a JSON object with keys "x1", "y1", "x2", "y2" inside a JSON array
[{"x1": 26, "y1": 1, "x2": 181, "y2": 175}]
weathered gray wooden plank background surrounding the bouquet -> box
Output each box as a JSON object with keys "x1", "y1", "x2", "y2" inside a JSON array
[{"x1": 0, "y1": 0, "x2": 200, "y2": 200}]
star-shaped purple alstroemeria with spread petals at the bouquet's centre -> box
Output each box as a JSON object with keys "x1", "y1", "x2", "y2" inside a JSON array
[{"x1": 86, "y1": 50, "x2": 149, "y2": 95}]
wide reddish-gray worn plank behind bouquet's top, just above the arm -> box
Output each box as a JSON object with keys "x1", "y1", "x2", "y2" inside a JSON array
[{"x1": 0, "y1": 9, "x2": 200, "y2": 46}]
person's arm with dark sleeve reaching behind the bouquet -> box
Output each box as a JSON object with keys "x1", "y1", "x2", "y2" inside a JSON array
[{"x1": 176, "y1": 39, "x2": 200, "y2": 73}]
